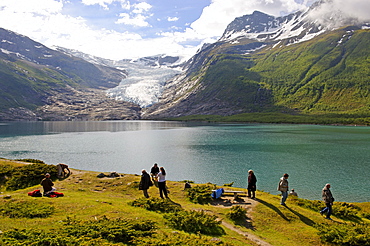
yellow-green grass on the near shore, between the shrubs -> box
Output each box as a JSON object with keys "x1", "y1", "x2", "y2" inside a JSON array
[{"x1": 0, "y1": 159, "x2": 370, "y2": 246}]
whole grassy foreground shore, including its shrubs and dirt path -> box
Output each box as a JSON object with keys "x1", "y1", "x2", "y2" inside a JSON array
[{"x1": 0, "y1": 159, "x2": 370, "y2": 246}]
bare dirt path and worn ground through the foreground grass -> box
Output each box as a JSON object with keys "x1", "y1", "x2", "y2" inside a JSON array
[{"x1": 212, "y1": 197, "x2": 272, "y2": 246}]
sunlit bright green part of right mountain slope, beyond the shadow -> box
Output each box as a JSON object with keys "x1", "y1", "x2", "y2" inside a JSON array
[{"x1": 251, "y1": 28, "x2": 370, "y2": 115}]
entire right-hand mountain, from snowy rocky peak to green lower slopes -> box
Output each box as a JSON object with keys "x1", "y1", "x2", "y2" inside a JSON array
[{"x1": 143, "y1": 1, "x2": 370, "y2": 118}]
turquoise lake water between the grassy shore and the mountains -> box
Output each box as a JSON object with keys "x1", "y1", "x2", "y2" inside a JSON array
[{"x1": 0, "y1": 121, "x2": 370, "y2": 202}]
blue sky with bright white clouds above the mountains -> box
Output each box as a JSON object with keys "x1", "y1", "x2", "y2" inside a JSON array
[{"x1": 0, "y1": 0, "x2": 370, "y2": 60}]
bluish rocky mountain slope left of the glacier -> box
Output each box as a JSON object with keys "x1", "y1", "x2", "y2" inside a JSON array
[{"x1": 0, "y1": 28, "x2": 140, "y2": 120}]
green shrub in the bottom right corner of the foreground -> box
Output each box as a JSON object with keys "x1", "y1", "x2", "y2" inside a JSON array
[{"x1": 317, "y1": 223, "x2": 370, "y2": 246}]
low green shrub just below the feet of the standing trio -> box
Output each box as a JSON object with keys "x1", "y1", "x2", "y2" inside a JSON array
[{"x1": 129, "y1": 197, "x2": 182, "y2": 213}]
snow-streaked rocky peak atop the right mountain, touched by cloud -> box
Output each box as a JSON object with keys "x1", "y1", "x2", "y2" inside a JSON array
[{"x1": 219, "y1": 0, "x2": 370, "y2": 45}]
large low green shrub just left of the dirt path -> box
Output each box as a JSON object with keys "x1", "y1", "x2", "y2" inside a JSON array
[{"x1": 164, "y1": 210, "x2": 223, "y2": 235}]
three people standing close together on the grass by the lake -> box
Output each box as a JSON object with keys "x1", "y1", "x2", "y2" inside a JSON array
[{"x1": 139, "y1": 163, "x2": 168, "y2": 199}]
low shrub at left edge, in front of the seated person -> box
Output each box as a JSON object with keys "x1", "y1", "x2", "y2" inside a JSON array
[{"x1": 0, "y1": 200, "x2": 55, "y2": 218}]
